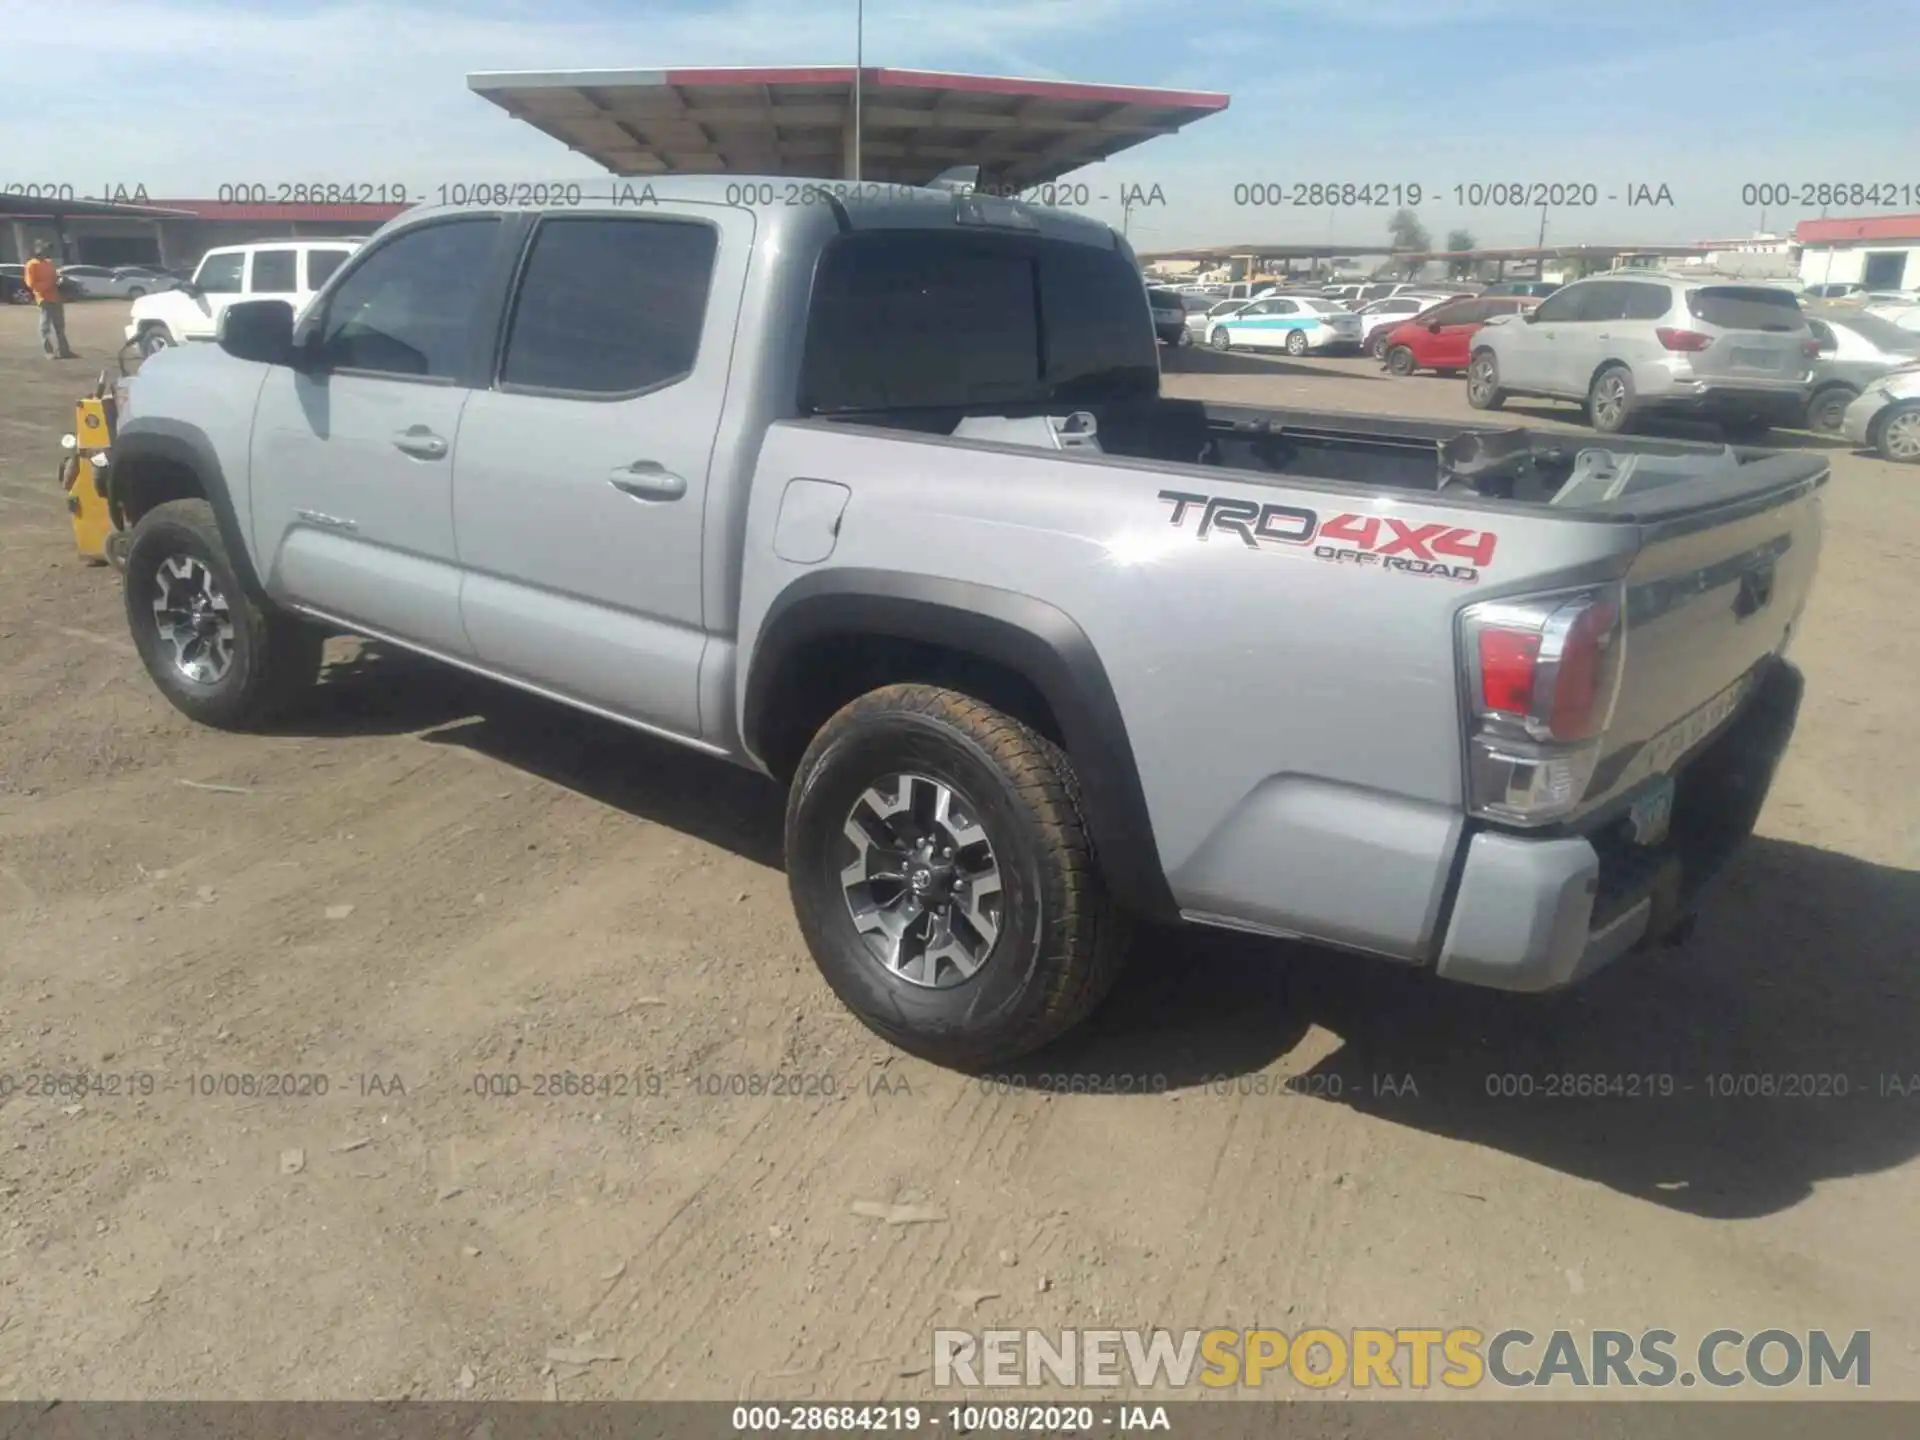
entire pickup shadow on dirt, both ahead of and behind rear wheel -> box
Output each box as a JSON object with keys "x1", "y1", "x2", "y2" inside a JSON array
[{"x1": 280, "y1": 649, "x2": 1920, "y2": 1219}]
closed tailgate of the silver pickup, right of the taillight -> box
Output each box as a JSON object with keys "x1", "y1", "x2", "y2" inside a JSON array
[{"x1": 1582, "y1": 455, "x2": 1828, "y2": 812}]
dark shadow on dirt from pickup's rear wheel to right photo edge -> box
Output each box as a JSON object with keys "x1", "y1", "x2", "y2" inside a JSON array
[{"x1": 1059, "y1": 839, "x2": 1920, "y2": 1219}]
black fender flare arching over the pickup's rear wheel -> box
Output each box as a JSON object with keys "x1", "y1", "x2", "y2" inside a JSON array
[{"x1": 741, "y1": 568, "x2": 1179, "y2": 920}]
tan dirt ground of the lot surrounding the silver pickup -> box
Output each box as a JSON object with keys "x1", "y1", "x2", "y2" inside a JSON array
[{"x1": 0, "y1": 303, "x2": 1920, "y2": 1400}]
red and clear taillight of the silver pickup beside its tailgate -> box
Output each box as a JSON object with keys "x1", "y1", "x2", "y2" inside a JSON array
[{"x1": 1461, "y1": 588, "x2": 1626, "y2": 824}]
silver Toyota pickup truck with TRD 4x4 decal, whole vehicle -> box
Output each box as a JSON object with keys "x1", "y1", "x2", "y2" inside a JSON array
[{"x1": 106, "y1": 179, "x2": 1826, "y2": 1066}]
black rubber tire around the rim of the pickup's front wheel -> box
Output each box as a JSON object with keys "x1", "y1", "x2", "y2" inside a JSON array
[{"x1": 123, "y1": 499, "x2": 326, "y2": 730}]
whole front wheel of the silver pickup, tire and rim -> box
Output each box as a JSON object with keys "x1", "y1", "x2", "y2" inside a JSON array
[{"x1": 123, "y1": 499, "x2": 326, "y2": 730}]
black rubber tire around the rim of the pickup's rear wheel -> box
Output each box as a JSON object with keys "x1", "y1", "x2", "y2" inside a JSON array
[{"x1": 785, "y1": 684, "x2": 1129, "y2": 1069}]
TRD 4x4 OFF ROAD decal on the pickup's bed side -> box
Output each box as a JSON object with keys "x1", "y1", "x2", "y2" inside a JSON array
[{"x1": 1160, "y1": 490, "x2": 1500, "y2": 584}]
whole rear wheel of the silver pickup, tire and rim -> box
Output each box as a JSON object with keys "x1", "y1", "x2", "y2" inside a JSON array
[{"x1": 785, "y1": 684, "x2": 1125, "y2": 1069}]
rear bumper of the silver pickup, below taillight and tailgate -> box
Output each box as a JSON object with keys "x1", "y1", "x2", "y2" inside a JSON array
[{"x1": 1436, "y1": 660, "x2": 1805, "y2": 991}]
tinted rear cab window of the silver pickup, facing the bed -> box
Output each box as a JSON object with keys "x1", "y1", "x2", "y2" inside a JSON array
[{"x1": 799, "y1": 230, "x2": 1160, "y2": 415}]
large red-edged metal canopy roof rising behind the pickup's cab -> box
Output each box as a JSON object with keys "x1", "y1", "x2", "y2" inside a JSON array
[{"x1": 467, "y1": 65, "x2": 1227, "y2": 188}]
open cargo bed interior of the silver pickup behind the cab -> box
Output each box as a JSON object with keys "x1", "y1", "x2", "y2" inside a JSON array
[{"x1": 814, "y1": 399, "x2": 1826, "y2": 518}]
